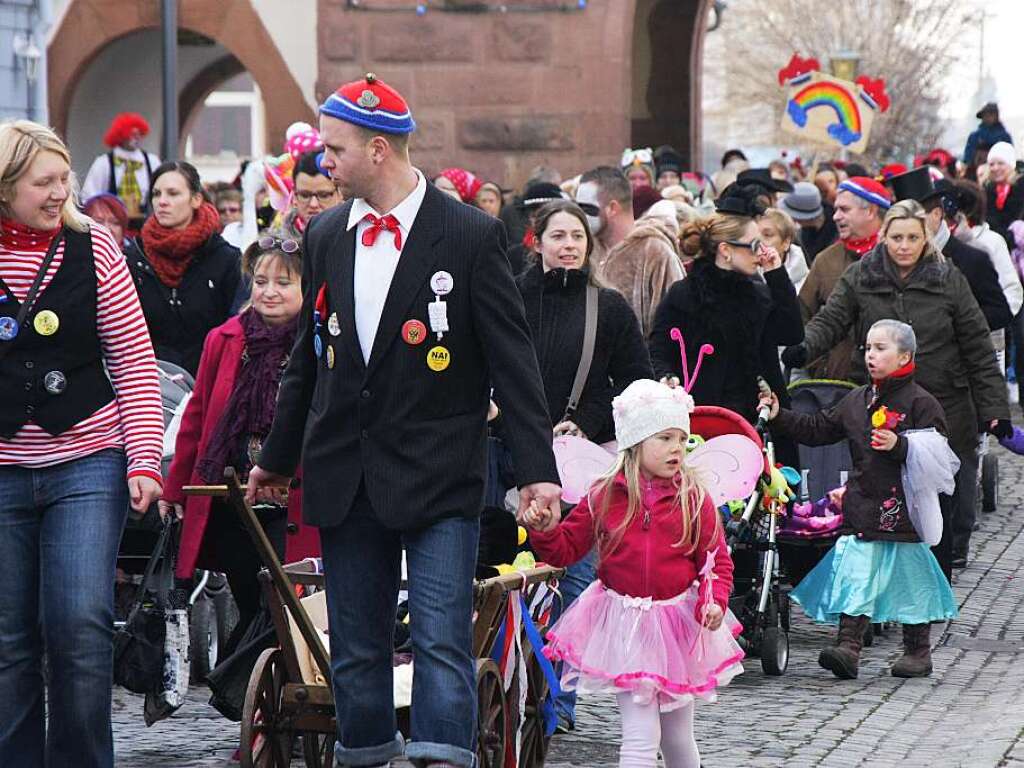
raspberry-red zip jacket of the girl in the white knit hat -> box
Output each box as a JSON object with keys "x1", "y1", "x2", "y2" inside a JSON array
[{"x1": 529, "y1": 474, "x2": 732, "y2": 610}]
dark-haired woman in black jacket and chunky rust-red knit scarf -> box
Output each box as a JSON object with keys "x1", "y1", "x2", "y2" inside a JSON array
[{"x1": 125, "y1": 162, "x2": 242, "y2": 375}]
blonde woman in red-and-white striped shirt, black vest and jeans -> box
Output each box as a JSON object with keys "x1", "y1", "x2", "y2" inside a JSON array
[{"x1": 0, "y1": 121, "x2": 163, "y2": 768}]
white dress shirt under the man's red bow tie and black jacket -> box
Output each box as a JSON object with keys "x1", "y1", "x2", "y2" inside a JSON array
[{"x1": 345, "y1": 169, "x2": 427, "y2": 362}]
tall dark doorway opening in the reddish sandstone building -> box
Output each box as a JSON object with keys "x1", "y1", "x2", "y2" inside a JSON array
[{"x1": 630, "y1": 0, "x2": 713, "y2": 168}]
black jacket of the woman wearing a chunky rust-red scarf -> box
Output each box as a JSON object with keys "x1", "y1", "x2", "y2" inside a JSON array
[{"x1": 125, "y1": 234, "x2": 242, "y2": 376}]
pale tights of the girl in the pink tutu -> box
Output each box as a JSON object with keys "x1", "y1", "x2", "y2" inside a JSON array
[{"x1": 617, "y1": 693, "x2": 700, "y2": 768}]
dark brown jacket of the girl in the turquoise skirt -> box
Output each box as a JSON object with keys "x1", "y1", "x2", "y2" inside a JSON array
[{"x1": 772, "y1": 374, "x2": 946, "y2": 542}]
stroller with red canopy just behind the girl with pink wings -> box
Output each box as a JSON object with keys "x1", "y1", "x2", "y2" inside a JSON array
[{"x1": 688, "y1": 406, "x2": 790, "y2": 675}]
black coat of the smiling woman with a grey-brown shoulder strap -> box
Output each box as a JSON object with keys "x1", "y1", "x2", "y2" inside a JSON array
[{"x1": 516, "y1": 263, "x2": 654, "y2": 442}]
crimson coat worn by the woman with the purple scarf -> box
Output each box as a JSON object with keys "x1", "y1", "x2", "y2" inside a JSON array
[{"x1": 163, "y1": 316, "x2": 319, "y2": 579}]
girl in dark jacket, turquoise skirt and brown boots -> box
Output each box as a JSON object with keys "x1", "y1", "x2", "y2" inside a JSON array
[{"x1": 762, "y1": 319, "x2": 957, "y2": 679}]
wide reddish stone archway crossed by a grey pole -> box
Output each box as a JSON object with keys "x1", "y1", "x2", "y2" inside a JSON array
[{"x1": 47, "y1": 0, "x2": 314, "y2": 174}]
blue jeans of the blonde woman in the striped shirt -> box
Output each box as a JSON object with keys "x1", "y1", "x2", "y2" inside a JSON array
[{"x1": 0, "y1": 451, "x2": 128, "y2": 768}]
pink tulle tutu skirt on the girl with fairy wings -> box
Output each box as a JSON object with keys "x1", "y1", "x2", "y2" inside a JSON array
[{"x1": 544, "y1": 581, "x2": 743, "y2": 712}]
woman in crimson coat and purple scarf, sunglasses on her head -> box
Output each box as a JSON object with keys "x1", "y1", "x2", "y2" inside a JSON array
[{"x1": 161, "y1": 238, "x2": 319, "y2": 657}]
